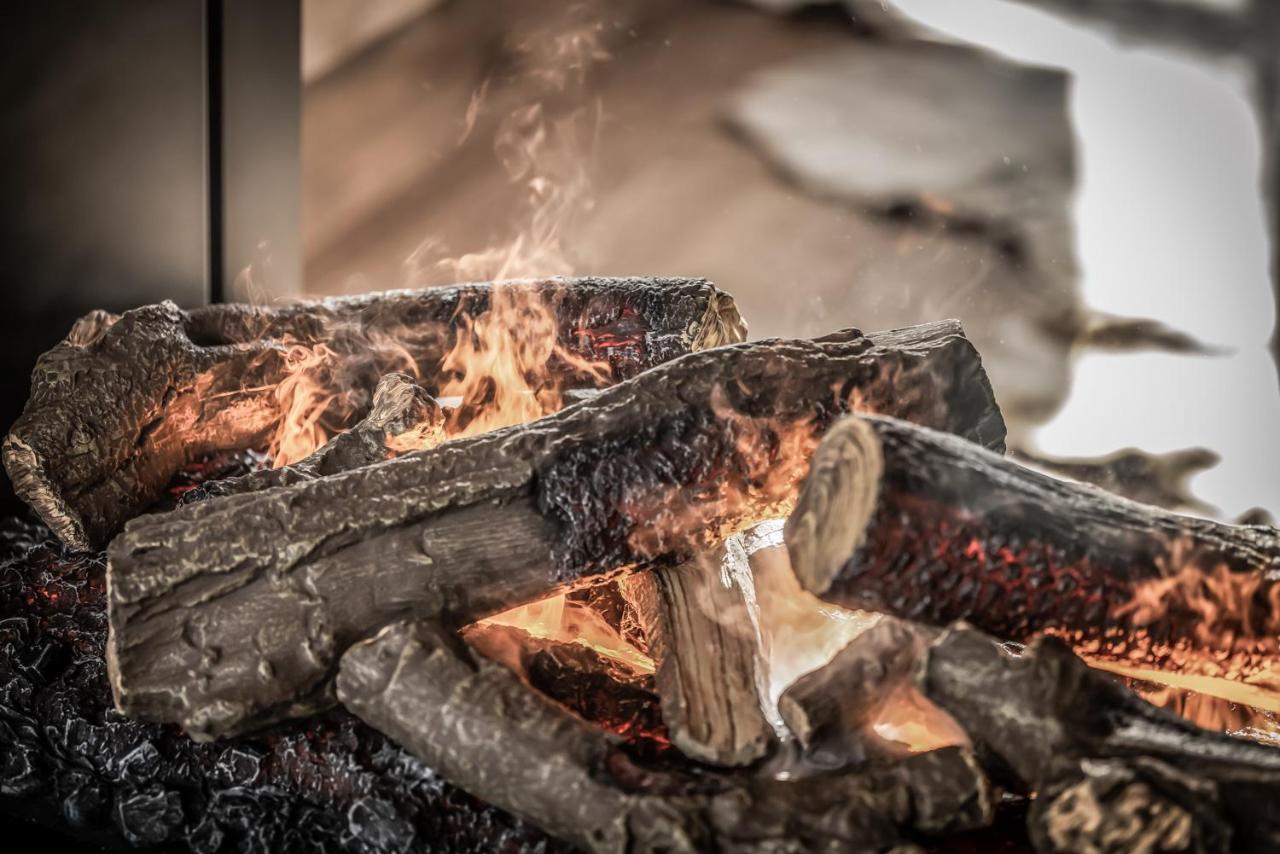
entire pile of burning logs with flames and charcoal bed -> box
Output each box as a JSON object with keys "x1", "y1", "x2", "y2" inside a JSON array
[{"x1": 0, "y1": 278, "x2": 1280, "y2": 851}]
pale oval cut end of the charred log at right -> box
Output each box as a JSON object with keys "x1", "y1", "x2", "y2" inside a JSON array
[{"x1": 785, "y1": 416, "x2": 884, "y2": 595}]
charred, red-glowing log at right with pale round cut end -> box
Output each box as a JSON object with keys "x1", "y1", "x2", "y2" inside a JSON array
[{"x1": 787, "y1": 416, "x2": 1280, "y2": 709}]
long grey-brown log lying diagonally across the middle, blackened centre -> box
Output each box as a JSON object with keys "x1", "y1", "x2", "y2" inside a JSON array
[{"x1": 108, "y1": 321, "x2": 1004, "y2": 739}]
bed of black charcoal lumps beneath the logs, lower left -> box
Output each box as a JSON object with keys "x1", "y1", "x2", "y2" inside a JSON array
[{"x1": 0, "y1": 520, "x2": 563, "y2": 854}]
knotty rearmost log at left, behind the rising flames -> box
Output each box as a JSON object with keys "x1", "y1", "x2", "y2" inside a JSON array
[{"x1": 4, "y1": 279, "x2": 745, "y2": 549}]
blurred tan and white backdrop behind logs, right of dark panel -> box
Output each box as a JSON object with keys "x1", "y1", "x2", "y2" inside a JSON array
[{"x1": 302, "y1": 0, "x2": 1280, "y2": 517}]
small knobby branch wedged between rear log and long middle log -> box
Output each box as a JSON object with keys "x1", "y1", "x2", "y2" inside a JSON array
[{"x1": 183, "y1": 373, "x2": 445, "y2": 503}]
